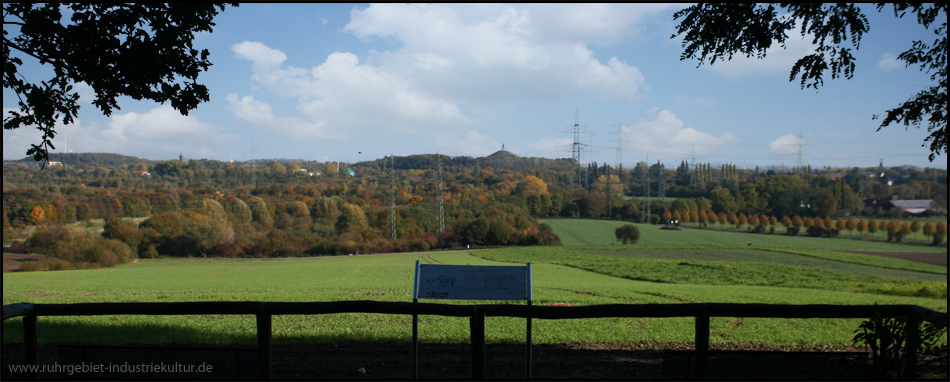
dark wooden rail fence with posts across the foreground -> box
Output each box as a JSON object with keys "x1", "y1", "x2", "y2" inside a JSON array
[{"x1": 3, "y1": 301, "x2": 947, "y2": 379}]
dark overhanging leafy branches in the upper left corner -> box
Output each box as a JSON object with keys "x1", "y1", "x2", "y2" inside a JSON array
[{"x1": 3, "y1": 3, "x2": 236, "y2": 162}]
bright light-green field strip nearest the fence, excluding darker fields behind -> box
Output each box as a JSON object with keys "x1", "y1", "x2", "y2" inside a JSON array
[{"x1": 3, "y1": 248, "x2": 947, "y2": 344}]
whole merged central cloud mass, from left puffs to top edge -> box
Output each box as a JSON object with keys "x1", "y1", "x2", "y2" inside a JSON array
[{"x1": 228, "y1": 4, "x2": 670, "y2": 155}]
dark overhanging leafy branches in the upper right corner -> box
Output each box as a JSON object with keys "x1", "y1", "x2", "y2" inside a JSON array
[{"x1": 672, "y1": 3, "x2": 947, "y2": 161}]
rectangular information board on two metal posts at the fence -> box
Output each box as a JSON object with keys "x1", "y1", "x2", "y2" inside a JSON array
[{"x1": 412, "y1": 260, "x2": 534, "y2": 379}]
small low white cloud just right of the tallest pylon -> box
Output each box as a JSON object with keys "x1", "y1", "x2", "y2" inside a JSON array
[{"x1": 623, "y1": 109, "x2": 739, "y2": 155}]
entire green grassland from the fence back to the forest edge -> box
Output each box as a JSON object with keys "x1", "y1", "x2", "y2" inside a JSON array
[{"x1": 3, "y1": 220, "x2": 947, "y2": 345}]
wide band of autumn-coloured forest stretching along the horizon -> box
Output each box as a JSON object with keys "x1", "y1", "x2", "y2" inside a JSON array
[{"x1": 3, "y1": 154, "x2": 947, "y2": 269}]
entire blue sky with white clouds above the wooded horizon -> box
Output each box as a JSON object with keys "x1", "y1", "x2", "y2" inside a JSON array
[{"x1": 3, "y1": 3, "x2": 947, "y2": 169}]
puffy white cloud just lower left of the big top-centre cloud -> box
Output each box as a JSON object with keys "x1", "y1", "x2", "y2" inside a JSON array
[{"x1": 229, "y1": 42, "x2": 472, "y2": 137}]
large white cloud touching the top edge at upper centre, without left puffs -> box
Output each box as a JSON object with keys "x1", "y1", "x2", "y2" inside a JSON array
[{"x1": 345, "y1": 4, "x2": 664, "y2": 103}]
